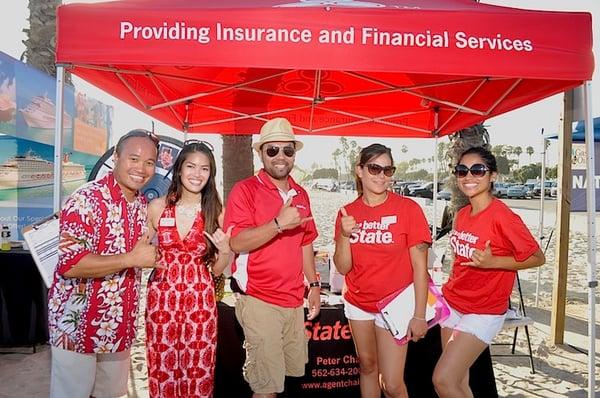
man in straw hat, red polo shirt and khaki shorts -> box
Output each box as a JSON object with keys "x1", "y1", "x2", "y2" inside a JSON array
[{"x1": 225, "y1": 118, "x2": 320, "y2": 397}]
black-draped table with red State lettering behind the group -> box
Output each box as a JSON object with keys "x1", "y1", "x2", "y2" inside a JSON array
[{"x1": 215, "y1": 303, "x2": 498, "y2": 398}]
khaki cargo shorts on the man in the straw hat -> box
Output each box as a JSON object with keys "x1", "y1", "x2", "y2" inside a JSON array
[{"x1": 235, "y1": 295, "x2": 308, "y2": 394}]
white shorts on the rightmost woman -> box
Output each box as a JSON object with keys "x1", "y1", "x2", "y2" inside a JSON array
[{"x1": 440, "y1": 305, "x2": 506, "y2": 344}]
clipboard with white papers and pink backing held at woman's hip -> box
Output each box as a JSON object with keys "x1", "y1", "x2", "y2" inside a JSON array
[{"x1": 377, "y1": 279, "x2": 450, "y2": 344}]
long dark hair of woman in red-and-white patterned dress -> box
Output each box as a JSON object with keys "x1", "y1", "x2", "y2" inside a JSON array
[{"x1": 167, "y1": 142, "x2": 223, "y2": 264}]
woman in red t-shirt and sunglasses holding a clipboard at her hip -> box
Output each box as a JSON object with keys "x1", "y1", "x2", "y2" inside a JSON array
[{"x1": 334, "y1": 144, "x2": 431, "y2": 397}]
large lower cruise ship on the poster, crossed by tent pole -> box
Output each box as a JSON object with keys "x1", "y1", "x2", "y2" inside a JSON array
[{"x1": 0, "y1": 151, "x2": 86, "y2": 189}]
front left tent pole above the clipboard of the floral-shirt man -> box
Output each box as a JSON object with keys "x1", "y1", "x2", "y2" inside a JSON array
[{"x1": 52, "y1": 65, "x2": 65, "y2": 212}]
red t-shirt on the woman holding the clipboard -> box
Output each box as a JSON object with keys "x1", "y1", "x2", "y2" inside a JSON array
[{"x1": 335, "y1": 192, "x2": 431, "y2": 312}]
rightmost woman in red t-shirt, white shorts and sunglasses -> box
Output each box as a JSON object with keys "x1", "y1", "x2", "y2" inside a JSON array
[{"x1": 433, "y1": 147, "x2": 546, "y2": 398}]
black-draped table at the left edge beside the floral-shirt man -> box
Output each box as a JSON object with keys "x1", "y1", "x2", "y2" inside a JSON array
[{"x1": 0, "y1": 249, "x2": 48, "y2": 348}]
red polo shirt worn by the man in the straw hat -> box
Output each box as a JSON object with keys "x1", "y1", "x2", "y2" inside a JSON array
[{"x1": 223, "y1": 170, "x2": 317, "y2": 308}]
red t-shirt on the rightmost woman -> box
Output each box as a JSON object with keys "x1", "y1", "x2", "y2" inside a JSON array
[{"x1": 442, "y1": 199, "x2": 539, "y2": 315}]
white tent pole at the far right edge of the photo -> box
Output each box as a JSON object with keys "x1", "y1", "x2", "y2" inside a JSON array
[{"x1": 583, "y1": 81, "x2": 598, "y2": 398}]
